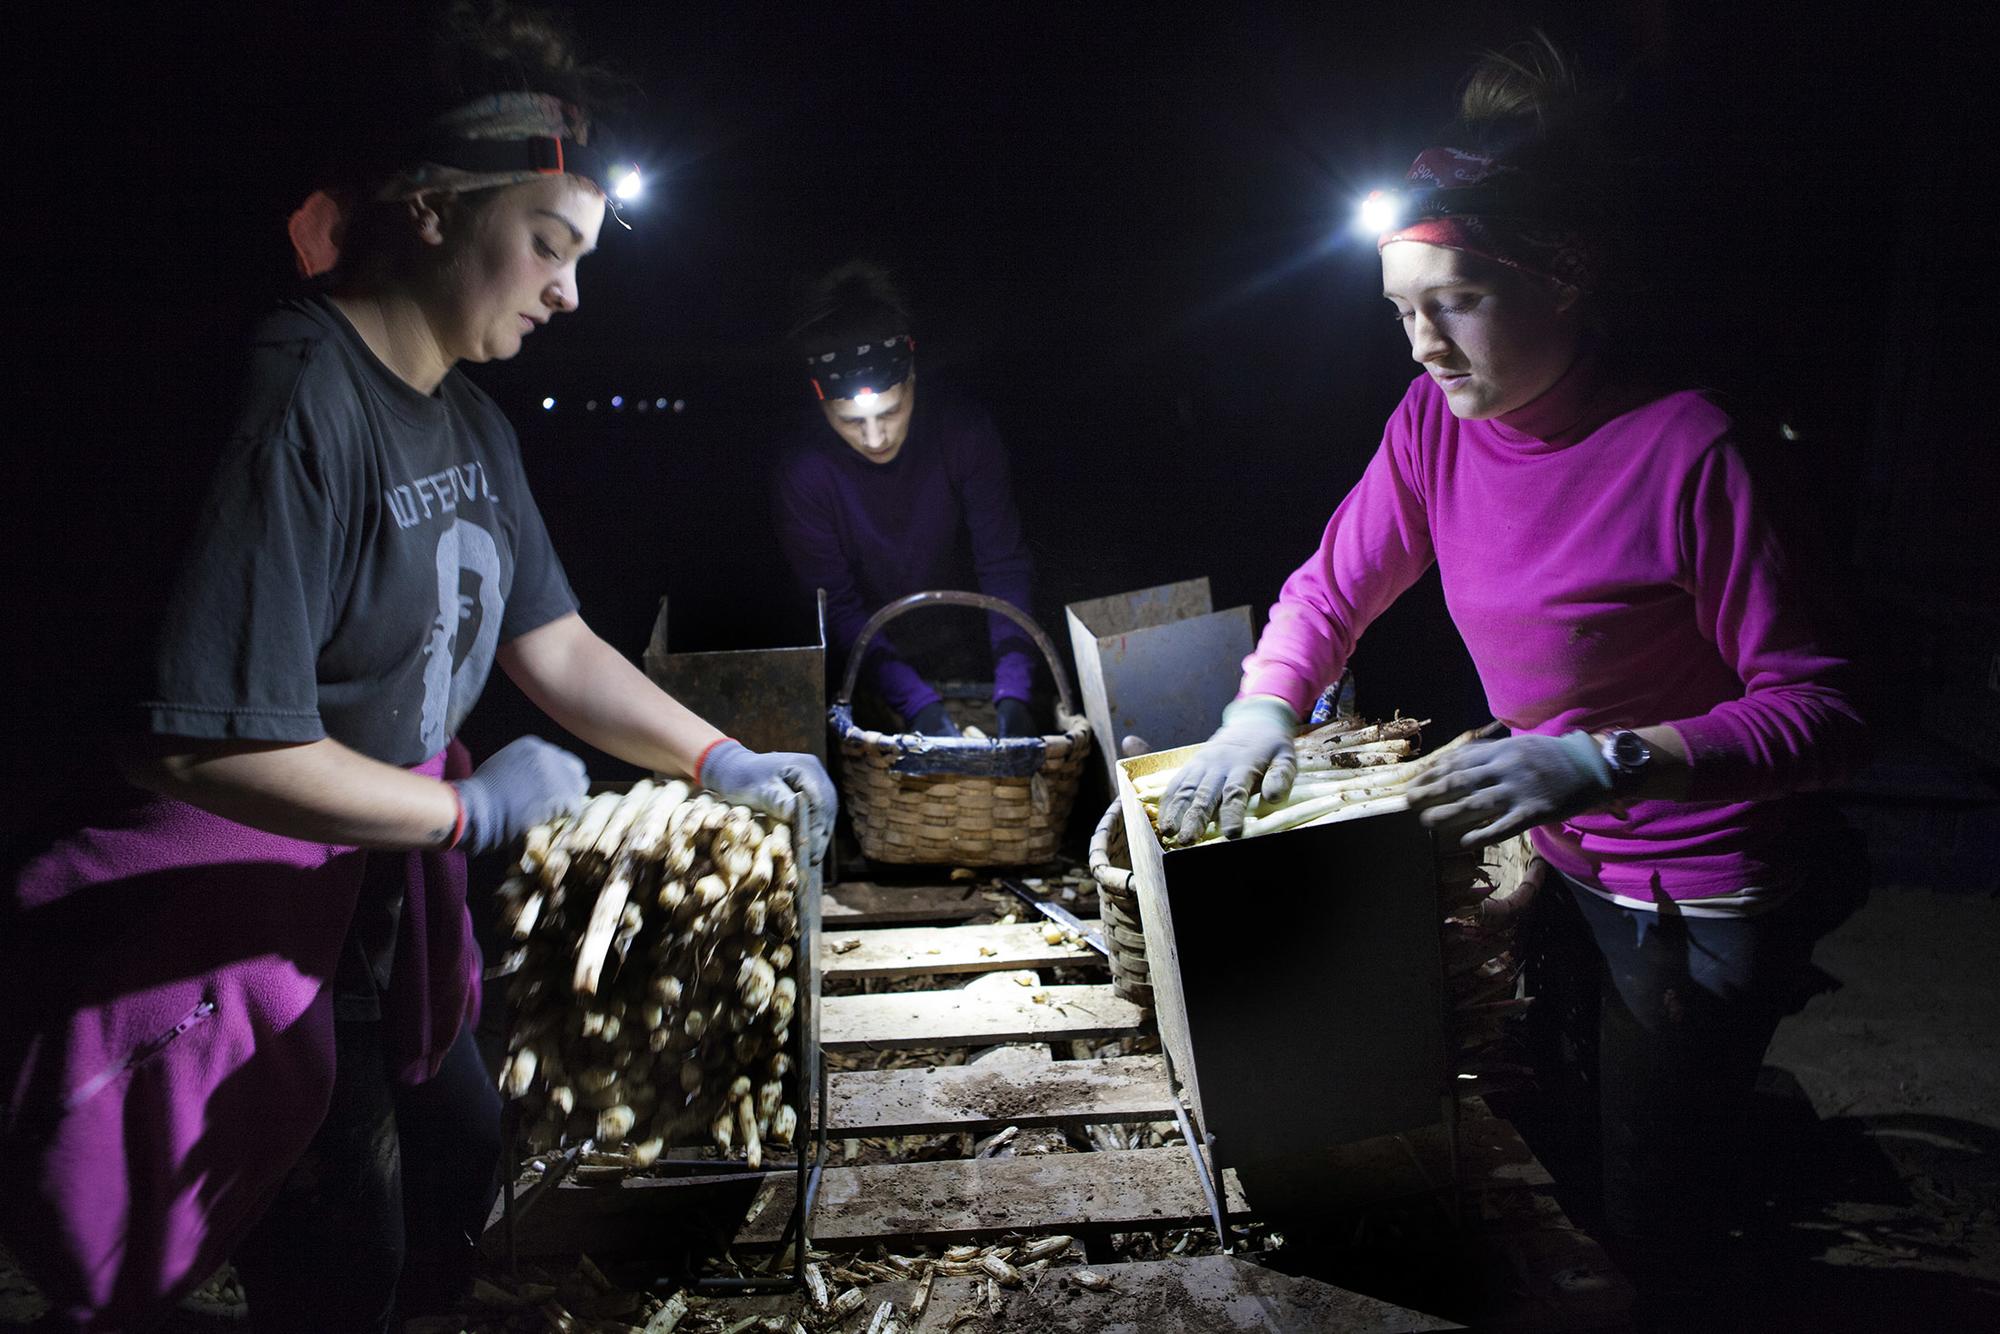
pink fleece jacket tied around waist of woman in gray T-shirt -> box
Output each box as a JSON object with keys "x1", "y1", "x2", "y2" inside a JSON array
[{"x1": 0, "y1": 744, "x2": 478, "y2": 1330}]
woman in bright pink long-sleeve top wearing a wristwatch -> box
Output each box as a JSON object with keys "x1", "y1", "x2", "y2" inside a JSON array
[{"x1": 1160, "y1": 39, "x2": 1862, "y2": 1304}]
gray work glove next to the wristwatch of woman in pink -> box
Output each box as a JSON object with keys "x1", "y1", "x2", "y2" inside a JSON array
[{"x1": 1408, "y1": 732, "x2": 1612, "y2": 848}]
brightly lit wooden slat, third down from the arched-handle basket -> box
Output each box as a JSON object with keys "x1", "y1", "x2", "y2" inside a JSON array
[{"x1": 820, "y1": 984, "x2": 1146, "y2": 1052}]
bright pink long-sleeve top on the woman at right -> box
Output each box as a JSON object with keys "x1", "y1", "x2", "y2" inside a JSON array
[{"x1": 1242, "y1": 356, "x2": 1864, "y2": 902}]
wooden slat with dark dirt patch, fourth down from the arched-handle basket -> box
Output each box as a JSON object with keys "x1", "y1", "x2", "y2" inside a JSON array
[{"x1": 826, "y1": 1056, "x2": 1174, "y2": 1134}]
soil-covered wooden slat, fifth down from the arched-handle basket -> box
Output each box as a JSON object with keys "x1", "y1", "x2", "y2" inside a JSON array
[{"x1": 736, "y1": 1148, "x2": 1248, "y2": 1248}]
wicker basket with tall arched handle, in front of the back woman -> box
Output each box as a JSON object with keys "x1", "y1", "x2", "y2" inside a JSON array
[{"x1": 828, "y1": 592, "x2": 1090, "y2": 866}]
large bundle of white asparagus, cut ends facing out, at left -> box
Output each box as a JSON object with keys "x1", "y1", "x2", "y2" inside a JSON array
[{"x1": 500, "y1": 782, "x2": 800, "y2": 1166}]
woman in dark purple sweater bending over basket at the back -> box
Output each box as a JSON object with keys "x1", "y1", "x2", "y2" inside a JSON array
[{"x1": 776, "y1": 264, "x2": 1040, "y2": 736}]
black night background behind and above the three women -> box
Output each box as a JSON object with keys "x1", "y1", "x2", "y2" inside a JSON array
[{"x1": 10, "y1": 0, "x2": 2000, "y2": 804}]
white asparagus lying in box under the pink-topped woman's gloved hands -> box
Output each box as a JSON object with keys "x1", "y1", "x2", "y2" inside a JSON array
[{"x1": 1132, "y1": 718, "x2": 1442, "y2": 842}]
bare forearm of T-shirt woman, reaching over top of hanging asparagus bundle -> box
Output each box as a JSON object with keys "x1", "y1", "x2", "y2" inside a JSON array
[{"x1": 498, "y1": 614, "x2": 722, "y2": 774}]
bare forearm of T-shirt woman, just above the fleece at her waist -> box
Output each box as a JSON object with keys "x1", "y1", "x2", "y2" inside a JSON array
[{"x1": 120, "y1": 740, "x2": 458, "y2": 850}]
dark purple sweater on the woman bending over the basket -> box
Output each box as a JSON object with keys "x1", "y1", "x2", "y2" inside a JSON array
[{"x1": 774, "y1": 386, "x2": 1034, "y2": 718}]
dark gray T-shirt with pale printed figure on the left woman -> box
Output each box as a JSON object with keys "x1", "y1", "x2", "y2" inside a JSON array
[{"x1": 142, "y1": 298, "x2": 576, "y2": 766}]
